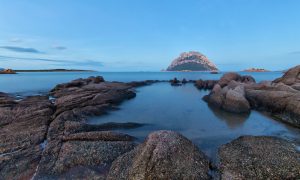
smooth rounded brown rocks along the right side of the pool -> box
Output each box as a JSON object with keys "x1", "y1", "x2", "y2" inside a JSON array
[{"x1": 203, "y1": 65, "x2": 300, "y2": 127}]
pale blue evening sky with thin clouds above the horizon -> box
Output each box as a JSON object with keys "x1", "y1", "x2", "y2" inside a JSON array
[{"x1": 0, "y1": 0, "x2": 300, "y2": 71}]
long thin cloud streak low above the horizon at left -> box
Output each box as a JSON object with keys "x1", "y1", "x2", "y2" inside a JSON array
[{"x1": 0, "y1": 55, "x2": 103, "y2": 66}]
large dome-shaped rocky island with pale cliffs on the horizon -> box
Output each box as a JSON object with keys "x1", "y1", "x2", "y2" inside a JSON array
[{"x1": 167, "y1": 51, "x2": 218, "y2": 72}]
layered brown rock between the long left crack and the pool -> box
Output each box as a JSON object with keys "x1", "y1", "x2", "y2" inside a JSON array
[{"x1": 36, "y1": 77, "x2": 135, "y2": 179}]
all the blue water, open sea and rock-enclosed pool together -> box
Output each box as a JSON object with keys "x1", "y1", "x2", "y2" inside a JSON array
[{"x1": 0, "y1": 72, "x2": 300, "y2": 161}]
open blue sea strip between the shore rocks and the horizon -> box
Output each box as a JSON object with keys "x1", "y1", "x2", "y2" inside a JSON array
[{"x1": 0, "y1": 72, "x2": 282, "y2": 95}]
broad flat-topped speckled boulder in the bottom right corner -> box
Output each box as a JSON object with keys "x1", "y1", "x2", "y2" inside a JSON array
[{"x1": 219, "y1": 136, "x2": 300, "y2": 180}]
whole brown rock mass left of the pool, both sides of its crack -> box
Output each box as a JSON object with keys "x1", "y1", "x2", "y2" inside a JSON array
[{"x1": 0, "y1": 77, "x2": 139, "y2": 179}]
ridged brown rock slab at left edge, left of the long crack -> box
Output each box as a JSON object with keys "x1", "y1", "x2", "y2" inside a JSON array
[{"x1": 0, "y1": 93, "x2": 54, "y2": 179}]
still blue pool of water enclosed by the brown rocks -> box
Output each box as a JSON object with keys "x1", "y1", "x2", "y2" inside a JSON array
[{"x1": 88, "y1": 83, "x2": 300, "y2": 160}]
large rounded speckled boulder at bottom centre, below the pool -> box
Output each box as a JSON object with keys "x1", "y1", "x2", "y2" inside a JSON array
[{"x1": 108, "y1": 131, "x2": 210, "y2": 179}]
